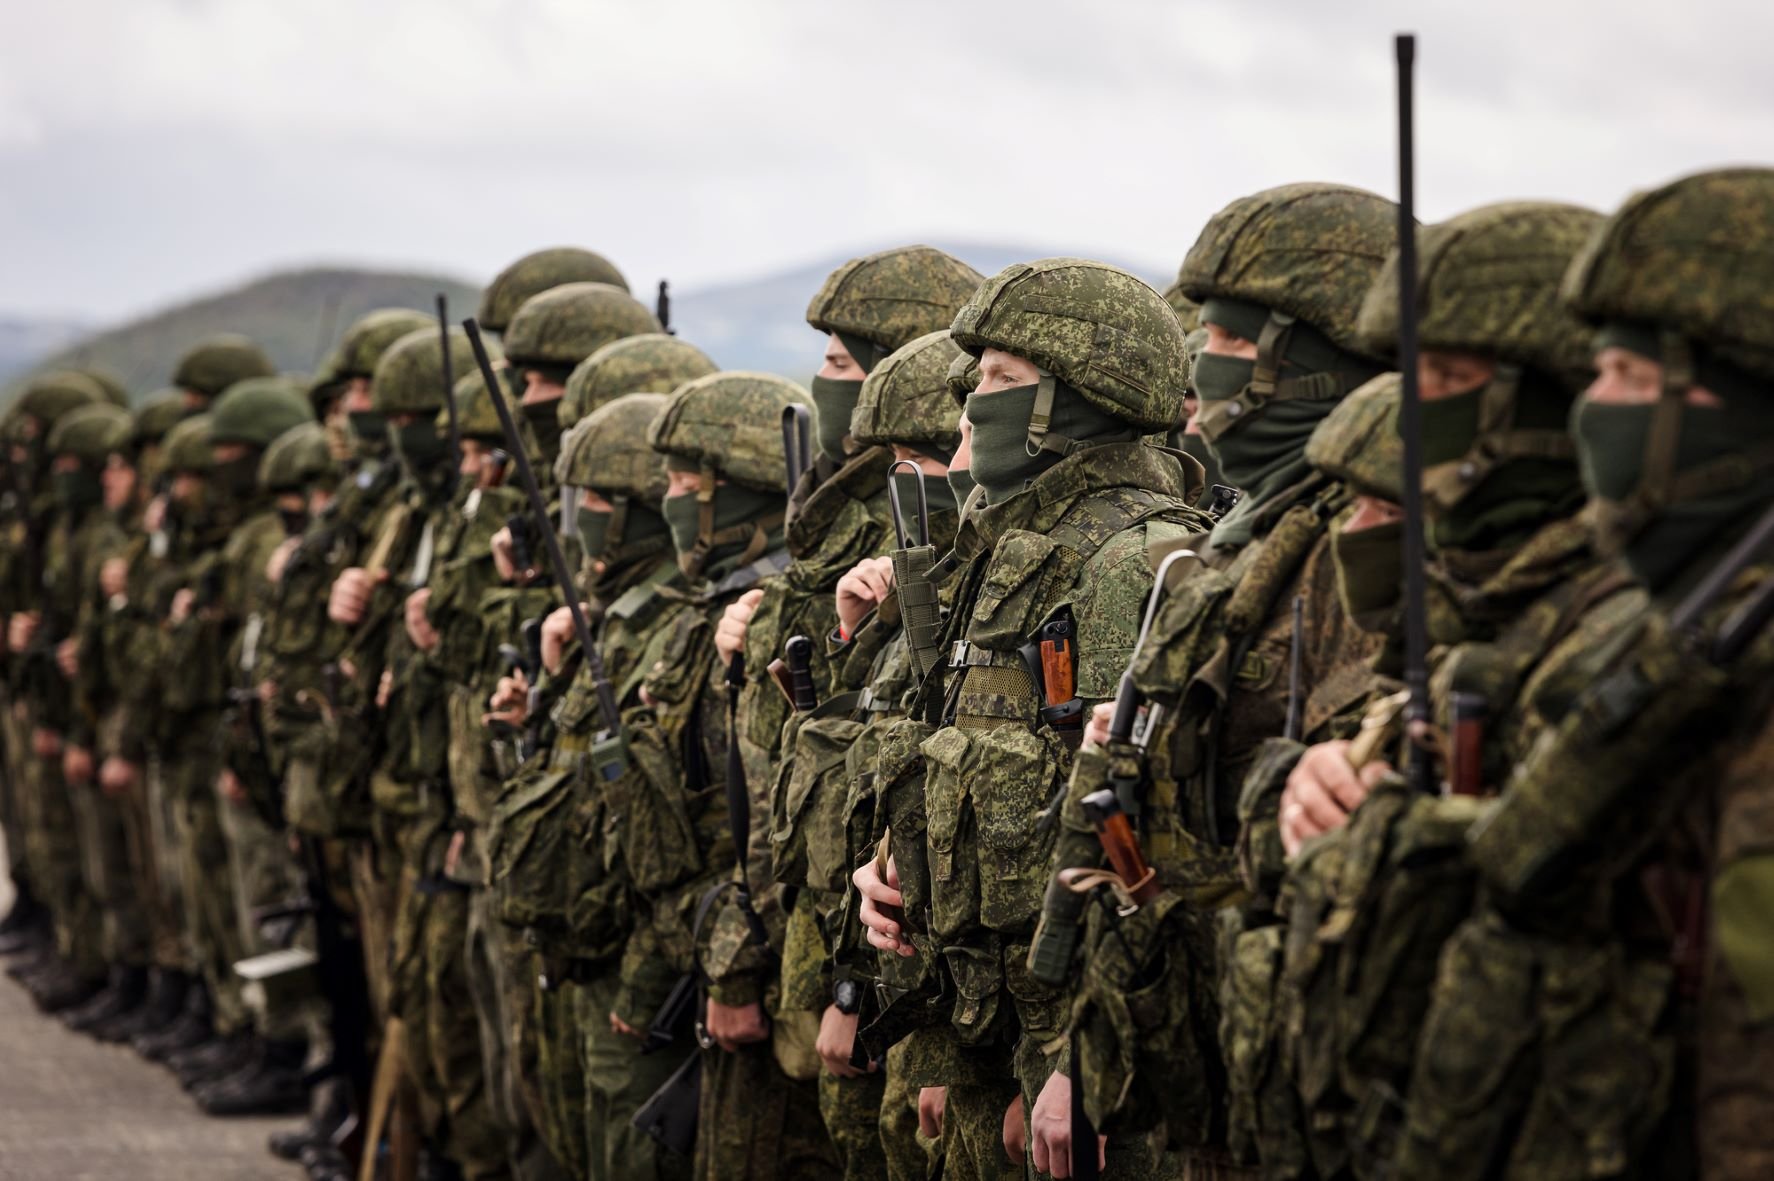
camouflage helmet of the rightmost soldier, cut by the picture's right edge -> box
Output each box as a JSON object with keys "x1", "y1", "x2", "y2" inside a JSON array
[{"x1": 1563, "y1": 168, "x2": 1774, "y2": 378}]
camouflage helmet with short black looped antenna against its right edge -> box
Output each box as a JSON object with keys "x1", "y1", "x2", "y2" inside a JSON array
[{"x1": 648, "y1": 371, "x2": 809, "y2": 493}]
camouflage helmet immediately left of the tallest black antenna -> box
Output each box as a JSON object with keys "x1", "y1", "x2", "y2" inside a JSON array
[{"x1": 1176, "y1": 183, "x2": 1398, "y2": 355}]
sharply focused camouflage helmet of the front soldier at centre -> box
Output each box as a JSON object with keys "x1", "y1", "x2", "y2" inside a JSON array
[{"x1": 954, "y1": 259, "x2": 1187, "y2": 430}]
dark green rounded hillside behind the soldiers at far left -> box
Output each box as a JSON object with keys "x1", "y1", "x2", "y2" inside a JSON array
[{"x1": 10, "y1": 268, "x2": 481, "y2": 401}]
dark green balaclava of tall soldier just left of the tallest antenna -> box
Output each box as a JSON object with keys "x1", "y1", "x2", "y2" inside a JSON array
[{"x1": 1190, "y1": 300, "x2": 1382, "y2": 507}]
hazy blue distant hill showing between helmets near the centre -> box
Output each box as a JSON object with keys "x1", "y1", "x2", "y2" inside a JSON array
[{"x1": 672, "y1": 241, "x2": 1174, "y2": 381}]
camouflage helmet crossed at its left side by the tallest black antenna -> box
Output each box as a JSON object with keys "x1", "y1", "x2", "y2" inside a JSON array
[{"x1": 1355, "y1": 200, "x2": 1602, "y2": 387}]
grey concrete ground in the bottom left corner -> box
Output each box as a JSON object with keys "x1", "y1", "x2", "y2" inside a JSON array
[{"x1": 0, "y1": 826, "x2": 303, "y2": 1181}]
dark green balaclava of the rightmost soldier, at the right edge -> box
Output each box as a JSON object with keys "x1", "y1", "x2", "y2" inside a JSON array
[{"x1": 1572, "y1": 325, "x2": 1774, "y2": 592}]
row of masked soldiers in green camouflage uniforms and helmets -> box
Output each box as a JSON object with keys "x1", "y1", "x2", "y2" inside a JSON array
[{"x1": 0, "y1": 158, "x2": 1774, "y2": 1181}]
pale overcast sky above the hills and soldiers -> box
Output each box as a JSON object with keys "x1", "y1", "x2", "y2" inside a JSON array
[{"x1": 0, "y1": 0, "x2": 1774, "y2": 319}]
